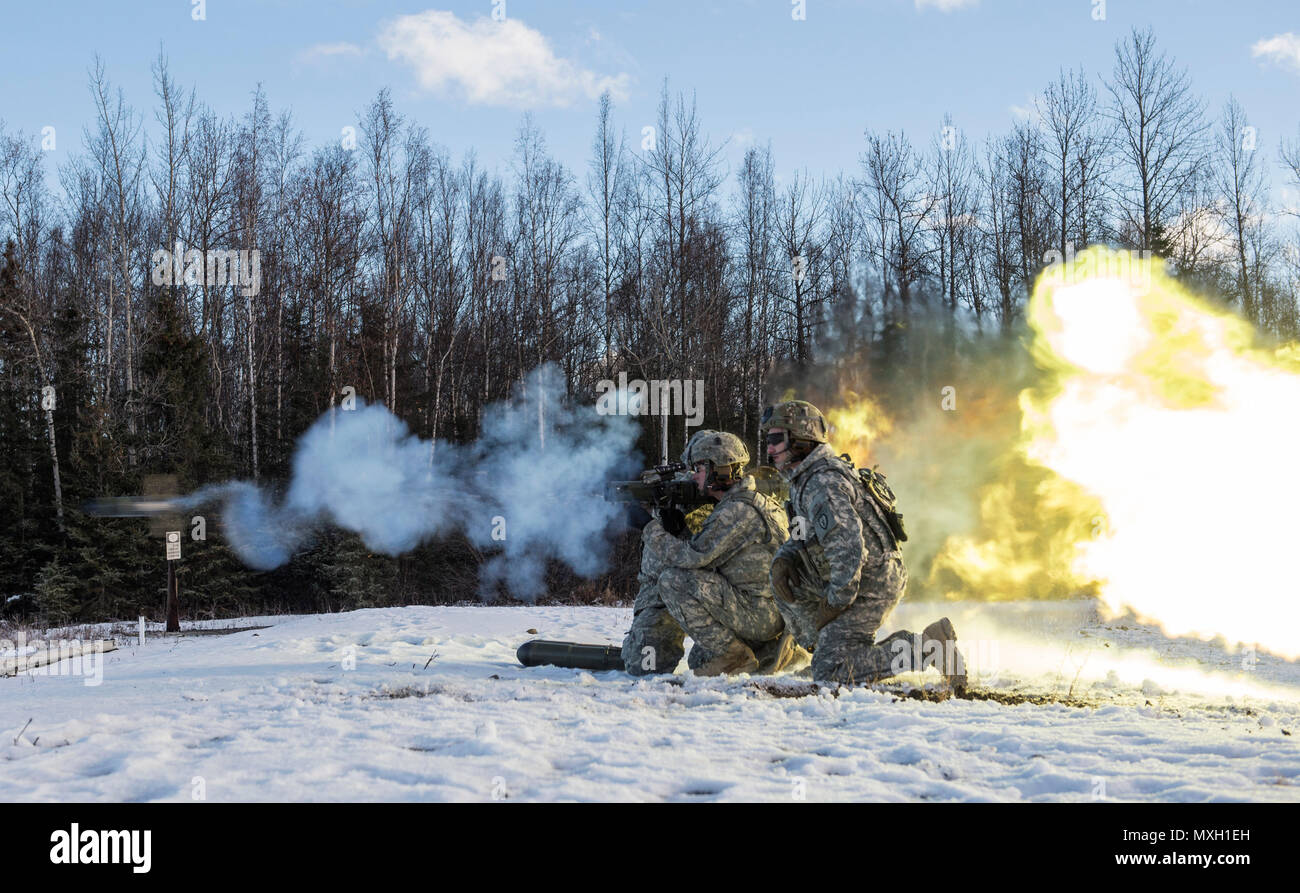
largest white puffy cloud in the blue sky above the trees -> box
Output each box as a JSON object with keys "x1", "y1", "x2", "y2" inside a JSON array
[{"x1": 378, "y1": 9, "x2": 631, "y2": 108}]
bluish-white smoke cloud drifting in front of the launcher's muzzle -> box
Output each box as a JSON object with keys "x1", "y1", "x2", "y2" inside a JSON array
[{"x1": 185, "y1": 365, "x2": 638, "y2": 599}]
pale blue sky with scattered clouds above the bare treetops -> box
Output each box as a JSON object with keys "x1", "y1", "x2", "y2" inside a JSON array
[{"x1": 0, "y1": 0, "x2": 1300, "y2": 198}]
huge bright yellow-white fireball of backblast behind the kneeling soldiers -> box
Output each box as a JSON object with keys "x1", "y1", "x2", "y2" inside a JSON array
[{"x1": 1021, "y1": 248, "x2": 1300, "y2": 658}]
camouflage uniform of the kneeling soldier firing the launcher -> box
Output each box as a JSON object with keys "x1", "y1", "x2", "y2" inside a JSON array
[{"x1": 623, "y1": 476, "x2": 789, "y2": 675}]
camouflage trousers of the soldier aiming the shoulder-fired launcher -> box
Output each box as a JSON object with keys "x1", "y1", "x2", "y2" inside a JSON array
[{"x1": 623, "y1": 538, "x2": 783, "y2": 676}]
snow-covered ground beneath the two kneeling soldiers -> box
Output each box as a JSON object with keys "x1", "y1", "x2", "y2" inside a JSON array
[{"x1": 0, "y1": 602, "x2": 1300, "y2": 801}]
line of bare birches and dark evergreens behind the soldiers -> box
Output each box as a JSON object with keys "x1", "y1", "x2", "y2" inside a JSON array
[{"x1": 0, "y1": 30, "x2": 1300, "y2": 620}]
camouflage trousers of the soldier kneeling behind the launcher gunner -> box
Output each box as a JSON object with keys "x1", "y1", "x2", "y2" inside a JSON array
[{"x1": 777, "y1": 545, "x2": 919, "y2": 685}]
